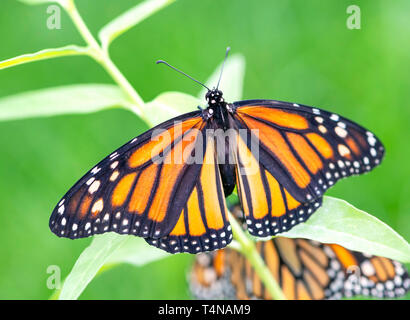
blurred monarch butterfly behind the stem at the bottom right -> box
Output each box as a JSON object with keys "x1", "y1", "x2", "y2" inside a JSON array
[{"x1": 189, "y1": 206, "x2": 410, "y2": 300}]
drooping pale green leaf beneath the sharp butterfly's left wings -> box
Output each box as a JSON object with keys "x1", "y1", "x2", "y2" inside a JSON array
[{"x1": 58, "y1": 232, "x2": 169, "y2": 300}]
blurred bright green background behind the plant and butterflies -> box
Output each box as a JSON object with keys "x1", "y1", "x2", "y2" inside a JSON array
[{"x1": 0, "y1": 0, "x2": 410, "y2": 299}]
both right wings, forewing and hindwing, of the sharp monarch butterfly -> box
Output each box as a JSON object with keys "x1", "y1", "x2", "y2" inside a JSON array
[{"x1": 231, "y1": 100, "x2": 384, "y2": 236}]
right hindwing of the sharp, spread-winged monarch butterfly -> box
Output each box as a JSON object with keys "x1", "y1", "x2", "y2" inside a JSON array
[{"x1": 232, "y1": 124, "x2": 322, "y2": 237}]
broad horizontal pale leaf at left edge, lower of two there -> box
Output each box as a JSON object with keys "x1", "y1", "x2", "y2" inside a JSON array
[{"x1": 0, "y1": 84, "x2": 132, "y2": 121}]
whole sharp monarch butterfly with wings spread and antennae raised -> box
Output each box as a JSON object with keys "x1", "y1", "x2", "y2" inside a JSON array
[{"x1": 49, "y1": 48, "x2": 384, "y2": 253}]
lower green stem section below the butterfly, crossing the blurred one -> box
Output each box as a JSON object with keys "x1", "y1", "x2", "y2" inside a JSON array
[{"x1": 228, "y1": 212, "x2": 286, "y2": 300}]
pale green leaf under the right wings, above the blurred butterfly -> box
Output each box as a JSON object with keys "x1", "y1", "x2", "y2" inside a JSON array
[{"x1": 279, "y1": 197, "x2": 410, "y2": 263}]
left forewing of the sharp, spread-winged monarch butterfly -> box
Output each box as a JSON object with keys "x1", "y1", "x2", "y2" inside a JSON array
[{"x1": 50, "y1": 112, "x2": 206, "y2": 238}]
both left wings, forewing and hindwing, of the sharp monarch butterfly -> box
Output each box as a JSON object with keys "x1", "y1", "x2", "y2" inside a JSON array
[{"x1": 50, "y1": 112, "x2": 230, "y2": 253}]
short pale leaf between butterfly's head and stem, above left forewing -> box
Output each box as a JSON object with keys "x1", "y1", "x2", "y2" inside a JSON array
[{"x1": 144, "y1": 92, "x2": 201, "y2": 125}]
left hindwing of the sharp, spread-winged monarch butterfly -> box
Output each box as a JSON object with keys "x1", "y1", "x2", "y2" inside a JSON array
[{"x1": 146, "y1": 132, "x2": 232, "y2": 253}]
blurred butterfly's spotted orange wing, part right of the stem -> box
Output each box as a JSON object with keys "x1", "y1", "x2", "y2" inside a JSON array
[{"x1": 262, "y1": 237, "x2": 410, "y2": 300}]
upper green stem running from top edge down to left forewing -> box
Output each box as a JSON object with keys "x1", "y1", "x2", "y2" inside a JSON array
[{"x1": 63, "y1": 0, "x2": 150, "y2": 124}]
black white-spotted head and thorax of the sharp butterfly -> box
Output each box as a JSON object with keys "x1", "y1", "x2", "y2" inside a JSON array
[{"x1": 205, "y1": 89, "x2": 229, "y2": 131}]
